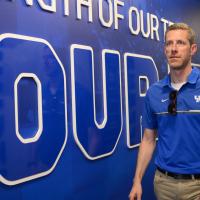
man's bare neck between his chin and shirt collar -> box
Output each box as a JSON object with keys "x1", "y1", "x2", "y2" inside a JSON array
[{"x1": 170, "y1": 65, "x2": 192, "y2": 83}]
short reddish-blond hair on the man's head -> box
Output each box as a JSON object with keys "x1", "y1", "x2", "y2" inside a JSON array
[{"x1": 165, "y1": 23, "x2": 196, "y2": 45}]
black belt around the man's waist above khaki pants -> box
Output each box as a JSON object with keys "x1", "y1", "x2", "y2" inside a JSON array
[{"x1": 157, "y1": 167, "x2": 200, "y2": 179}]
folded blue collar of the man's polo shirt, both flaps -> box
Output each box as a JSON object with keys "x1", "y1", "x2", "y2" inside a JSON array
[{"x1": 161, "y1": 67, "x2": 200, "y2": 87}]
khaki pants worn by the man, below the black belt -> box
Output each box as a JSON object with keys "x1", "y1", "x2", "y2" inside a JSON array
[{"x1": 154, "y1": 170, "x2": 200, "y2": 200}]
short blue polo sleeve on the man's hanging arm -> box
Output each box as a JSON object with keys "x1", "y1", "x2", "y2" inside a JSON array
[{"x1": 143, "y1": 92, "x2": 158, "y2": 129}]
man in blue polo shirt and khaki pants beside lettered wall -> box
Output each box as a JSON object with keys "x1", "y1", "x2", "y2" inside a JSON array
[{"x1": 129, "y1": 23, "x2": 200, "y2": 200}]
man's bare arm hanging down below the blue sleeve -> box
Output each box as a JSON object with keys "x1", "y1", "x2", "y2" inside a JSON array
[{"x1": 129, "y1": 129, "x2": 156, "y2": 200}]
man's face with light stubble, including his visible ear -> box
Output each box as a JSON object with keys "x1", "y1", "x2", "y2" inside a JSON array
[{"x1": 165, "y1": 30, "x2": 197, "y2": 70}]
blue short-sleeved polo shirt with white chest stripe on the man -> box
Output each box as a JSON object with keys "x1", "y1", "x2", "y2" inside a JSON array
[{"x1": 143, "y1": 68, "x2": 200, "y2": 174}]
